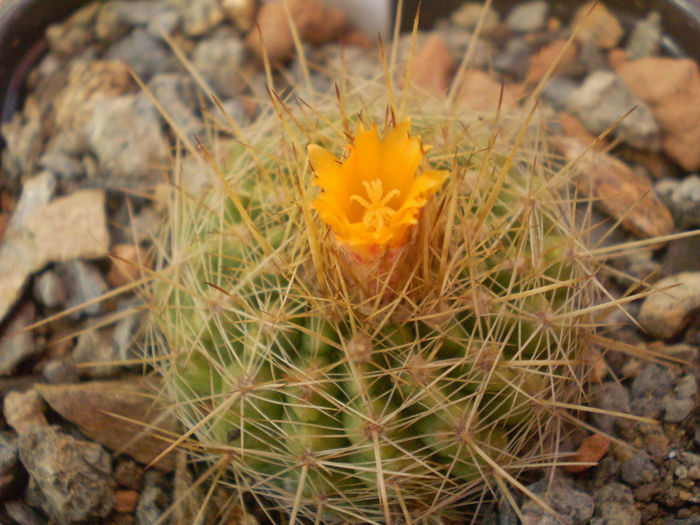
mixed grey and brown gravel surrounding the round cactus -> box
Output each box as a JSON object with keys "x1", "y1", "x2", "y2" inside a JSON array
[{"x1": 0, "y1": 0, "x2": 700, "y2": 525}]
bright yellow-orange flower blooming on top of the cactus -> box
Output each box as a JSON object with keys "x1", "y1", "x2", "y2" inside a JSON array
[{"x1": 309, "y1": 119, "x2": 448, "y2": 254}]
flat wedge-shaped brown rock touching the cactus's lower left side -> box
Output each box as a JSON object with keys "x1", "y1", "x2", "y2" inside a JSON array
[{"x1": 37, "y1": 378, "x2": 177, "y2": 471}]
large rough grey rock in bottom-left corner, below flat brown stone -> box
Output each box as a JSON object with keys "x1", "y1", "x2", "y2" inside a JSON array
[{"x1": 18, "y1": 427, "x2": 114, "y2": 523}]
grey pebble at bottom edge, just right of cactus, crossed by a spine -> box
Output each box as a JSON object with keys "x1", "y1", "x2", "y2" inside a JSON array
[{"x1": 521, "y1": 478, "x2": 594, "y2": 525}]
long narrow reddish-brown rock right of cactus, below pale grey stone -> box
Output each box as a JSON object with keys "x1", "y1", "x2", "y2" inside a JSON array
[{"x1": 556, "y1": 137, "x2": 673, "y2": 237}]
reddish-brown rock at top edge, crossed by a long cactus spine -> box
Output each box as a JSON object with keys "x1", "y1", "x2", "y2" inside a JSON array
[{"x1": 246, "y1": 0, "x2": 349, "y2": 62}]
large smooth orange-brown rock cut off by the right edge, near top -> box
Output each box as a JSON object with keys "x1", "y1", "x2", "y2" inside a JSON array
[{"x1": 615, "y1": 57, "x2": 700, "y2": 171}]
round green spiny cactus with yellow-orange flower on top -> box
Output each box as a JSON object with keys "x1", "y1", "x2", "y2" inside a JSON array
[{"x1": 150, "y1": 34, "x2": 599, "y2": 523}]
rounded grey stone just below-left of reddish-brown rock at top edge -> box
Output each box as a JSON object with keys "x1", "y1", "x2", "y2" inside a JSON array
[{"x1": 192, "y1": 27, "x2": 247, "y2": 99}]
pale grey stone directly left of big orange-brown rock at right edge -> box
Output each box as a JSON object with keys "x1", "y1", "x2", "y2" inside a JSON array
[{"x1": 567, "y1": 70, "x2": 661, "y2": 150}]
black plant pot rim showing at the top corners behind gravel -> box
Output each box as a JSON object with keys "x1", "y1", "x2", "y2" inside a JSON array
[{"x1": 0, "y1": 0, "x2": 700, "y2": 124}]
